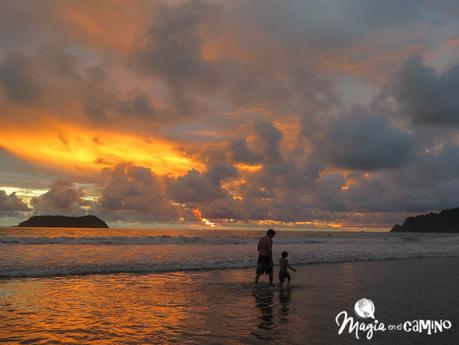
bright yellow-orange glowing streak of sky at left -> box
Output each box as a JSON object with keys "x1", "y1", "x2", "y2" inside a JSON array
[{"x1": 0, "y1": 122, "x2": 202, "y2": 176}]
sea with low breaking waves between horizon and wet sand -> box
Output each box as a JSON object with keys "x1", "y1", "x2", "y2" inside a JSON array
[{"x1": 0, "y1": 228, "x2": 459, "y2": 278}]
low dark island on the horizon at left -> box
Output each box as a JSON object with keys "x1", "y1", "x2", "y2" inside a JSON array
[{"x1": 18, "y1": 215, "x2": 108, "y2": 228}]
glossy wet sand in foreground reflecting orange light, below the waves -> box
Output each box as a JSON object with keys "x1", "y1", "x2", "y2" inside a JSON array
[{"x1": 0, "y1": 258, "x2": 459, "y2": 344}]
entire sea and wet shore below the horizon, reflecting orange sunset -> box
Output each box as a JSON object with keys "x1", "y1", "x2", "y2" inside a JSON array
[{"x1": 0, "y1": 228, "x2": 459, "y2": 344}]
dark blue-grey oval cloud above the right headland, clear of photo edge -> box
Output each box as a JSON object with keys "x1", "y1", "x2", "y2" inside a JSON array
[{"x1": 317, "y1": 110, "x2": 412, "y2": 170}]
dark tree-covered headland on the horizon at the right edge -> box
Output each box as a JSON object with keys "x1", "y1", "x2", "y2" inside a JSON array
[{"x1": 391, "y1": 207, "x2": 459, "y2": 233}]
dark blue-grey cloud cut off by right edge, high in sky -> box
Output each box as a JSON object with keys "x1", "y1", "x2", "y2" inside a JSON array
[{"x1": 393, "y1": 56, "x2": 459, "y2": 126}]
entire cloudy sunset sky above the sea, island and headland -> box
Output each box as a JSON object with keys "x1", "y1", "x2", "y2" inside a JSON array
[{"x1": 0, "y1": 0, "x2": 459, "y2": 229}]
